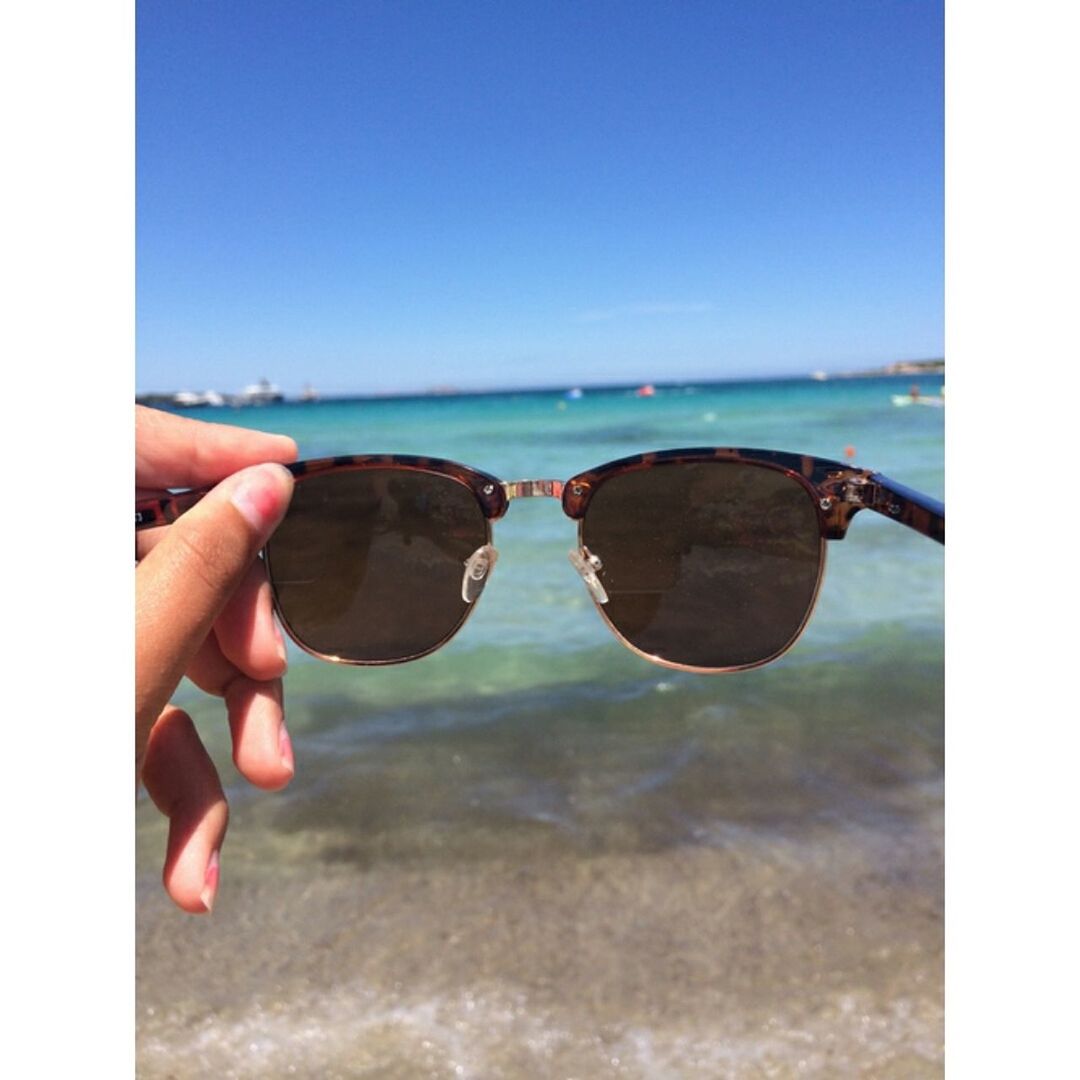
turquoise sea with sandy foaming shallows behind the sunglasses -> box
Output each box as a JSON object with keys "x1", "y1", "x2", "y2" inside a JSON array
[{"x1": 137, "y1": 377, "x2": 944, "y2": 1077}]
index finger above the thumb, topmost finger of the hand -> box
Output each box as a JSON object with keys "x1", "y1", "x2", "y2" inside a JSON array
[{"x1": 135, "y1": 405, "x2": 296, "y2": 488}]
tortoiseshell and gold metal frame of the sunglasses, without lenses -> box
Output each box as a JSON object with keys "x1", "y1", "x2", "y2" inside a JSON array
[{"x1": 135, "y1": 447, "x2": 945, "y2": 673}]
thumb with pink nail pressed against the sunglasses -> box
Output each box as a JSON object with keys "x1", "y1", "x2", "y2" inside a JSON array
[{"x1": 135, "y1": 464, "x2": 293, "y2": 761}]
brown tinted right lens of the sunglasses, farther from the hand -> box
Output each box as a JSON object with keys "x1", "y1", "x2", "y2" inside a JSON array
[{"x1": 581, "y1": 461, "x2": 824, "y2": 669}]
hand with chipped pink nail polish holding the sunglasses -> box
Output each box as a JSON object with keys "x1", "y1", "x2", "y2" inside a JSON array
[{"x1": 135, "y1": 406, "x2": 297, "y2": 914}]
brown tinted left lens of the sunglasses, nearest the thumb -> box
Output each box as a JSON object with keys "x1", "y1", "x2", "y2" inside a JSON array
[{"x1": 266, "y1": 468, "x2": 488, "y2": 663}]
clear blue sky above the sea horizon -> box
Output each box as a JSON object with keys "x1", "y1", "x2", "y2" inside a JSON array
[{"x1": 136, "y1": 0, "x2": 944, "y2": 393}]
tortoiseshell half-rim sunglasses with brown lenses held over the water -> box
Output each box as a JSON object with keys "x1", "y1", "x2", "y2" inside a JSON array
[{"x1": 135, "y1": 449, "x2": 945, "y2": 673}]
